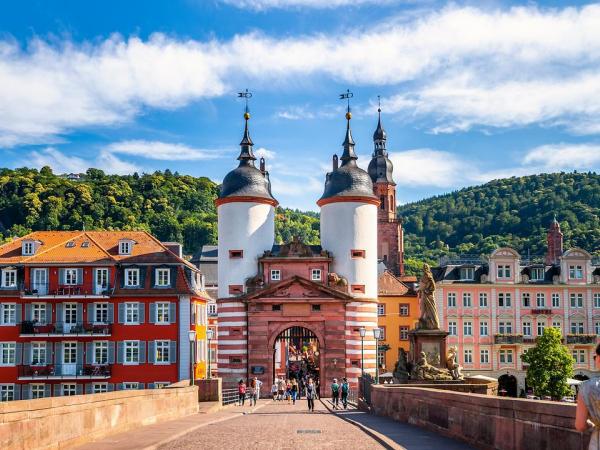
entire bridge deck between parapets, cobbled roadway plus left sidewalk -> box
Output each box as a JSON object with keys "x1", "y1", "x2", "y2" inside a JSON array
[{"x1": 78, "y1": 399, "x2": 472, "y2": 450}]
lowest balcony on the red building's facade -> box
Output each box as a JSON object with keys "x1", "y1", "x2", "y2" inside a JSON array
[{"x1": 18, "y1": 364, "x2": 112, "y2": 380}]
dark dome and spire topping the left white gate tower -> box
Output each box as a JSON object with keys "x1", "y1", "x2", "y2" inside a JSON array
[{"x1": 219, "y1": 113, "x2": 277, "y2": 201}]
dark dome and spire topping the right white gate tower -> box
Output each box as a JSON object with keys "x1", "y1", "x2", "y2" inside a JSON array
[{"x1": 320, "y1": 112, "x2": 376, "y2": 200}]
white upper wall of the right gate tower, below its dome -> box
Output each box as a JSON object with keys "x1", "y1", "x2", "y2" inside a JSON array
[{"x1": 321, "y1": 202, "x2": 377, "y2": 299}]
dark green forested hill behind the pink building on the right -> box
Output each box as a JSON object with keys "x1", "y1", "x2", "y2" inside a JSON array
[{"x1": 398, "y1": 173, "x2": 600, "y2": 268}]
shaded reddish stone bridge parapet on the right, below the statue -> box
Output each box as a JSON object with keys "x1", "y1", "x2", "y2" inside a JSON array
[{"x1": 371, "y1": 386, "x2": 589, "y2": 450}]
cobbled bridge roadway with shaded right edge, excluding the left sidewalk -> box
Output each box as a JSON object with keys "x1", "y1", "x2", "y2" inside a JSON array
[{"x1": 160, "y1": 400, "x2": 470, "y2": 450}]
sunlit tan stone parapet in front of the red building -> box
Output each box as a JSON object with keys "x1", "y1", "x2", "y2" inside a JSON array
[{"x1": 0, "y1": 382, "x2": 198, "y2": 450}]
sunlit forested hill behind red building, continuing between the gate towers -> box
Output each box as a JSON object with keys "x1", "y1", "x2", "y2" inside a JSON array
[{"x1": 0, "y1": 167, "x2": 319, "y2": 254}]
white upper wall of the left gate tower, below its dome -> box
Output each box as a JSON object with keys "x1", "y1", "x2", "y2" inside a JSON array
[{"x1": 217, "y1": 202, "x2": 275, "y2": 298}]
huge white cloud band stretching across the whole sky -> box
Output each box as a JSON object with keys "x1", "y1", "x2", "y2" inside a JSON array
[{"x1": 0, "y1": 0, "x2": 600, "y2": 146}]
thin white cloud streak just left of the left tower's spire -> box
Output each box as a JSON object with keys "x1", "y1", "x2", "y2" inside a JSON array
[{"x1": 106, "y1": 140, "x2": 224, "y2": 161}]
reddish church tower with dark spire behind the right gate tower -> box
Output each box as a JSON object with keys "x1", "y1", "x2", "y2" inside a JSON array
[{"x1": 369, "y1": 108, "x2": 404, "y2": 276}]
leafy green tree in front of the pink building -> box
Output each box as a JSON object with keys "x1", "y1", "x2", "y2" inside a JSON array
[{"x1": 522, "y1": 327, "x2": 573, "y2": 400}]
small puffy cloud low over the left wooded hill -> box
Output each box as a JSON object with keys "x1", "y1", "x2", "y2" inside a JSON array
[{"x1": 23, "y1": 147, "x2": 140, "y2": 175}]
